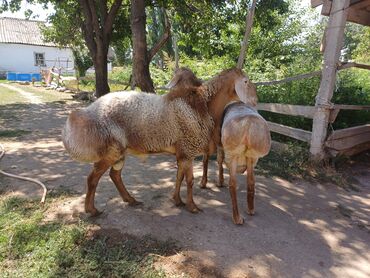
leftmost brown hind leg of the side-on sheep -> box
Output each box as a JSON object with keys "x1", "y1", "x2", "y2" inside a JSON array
[{"x1": 85, "y1": 161, "x2": 110, "y2": 216}]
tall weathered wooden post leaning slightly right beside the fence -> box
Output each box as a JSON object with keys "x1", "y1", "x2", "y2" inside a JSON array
[{"x1": 310, "y1": 0, "x2": 350, "y2": 161}]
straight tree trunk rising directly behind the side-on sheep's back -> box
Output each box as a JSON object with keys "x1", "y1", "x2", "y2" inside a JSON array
[{"x1": 131, "y1": 0, "x2": 155, "y2": 93}]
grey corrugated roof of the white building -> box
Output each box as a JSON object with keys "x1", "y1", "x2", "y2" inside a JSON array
[{"x1": 0, "y1": 17, "x2": 56, "y2": 46}]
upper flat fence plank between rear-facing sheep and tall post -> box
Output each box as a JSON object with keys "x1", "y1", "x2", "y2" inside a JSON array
[{"x1": 257, "y1": 103, "x2": 315, "y2": 119}]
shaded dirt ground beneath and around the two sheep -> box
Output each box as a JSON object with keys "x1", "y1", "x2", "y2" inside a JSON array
[{"x1": 0, "y1": 88, "x2": 370, "y2": 278}]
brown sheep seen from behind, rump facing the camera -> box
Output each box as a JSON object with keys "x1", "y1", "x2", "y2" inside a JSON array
[{"x1": 167, "y1": 69, "x2": 271, "y2": 224}]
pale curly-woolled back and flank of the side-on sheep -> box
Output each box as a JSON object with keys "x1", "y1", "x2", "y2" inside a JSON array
[{"x1": 80, "y1": 91, "x2": 212, "y2": 156}]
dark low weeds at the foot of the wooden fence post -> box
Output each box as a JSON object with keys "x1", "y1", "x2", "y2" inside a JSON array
[{"x1": 256, "y1": 143, "x2": 354, "y2": 189}]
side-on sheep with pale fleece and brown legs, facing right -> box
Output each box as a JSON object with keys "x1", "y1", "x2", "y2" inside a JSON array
[{"x1": 62, "y1": 69, "x2": 256, "y2": 215}]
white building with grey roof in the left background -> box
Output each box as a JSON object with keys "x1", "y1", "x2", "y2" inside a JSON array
[{"x1": 0, "y1": 17, "x2": 74, "y2": 76}]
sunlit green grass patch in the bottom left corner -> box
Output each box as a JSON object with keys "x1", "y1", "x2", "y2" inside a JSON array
[{"x1": 0, "y1": 196, "x2": 175, "y2": 277}]
